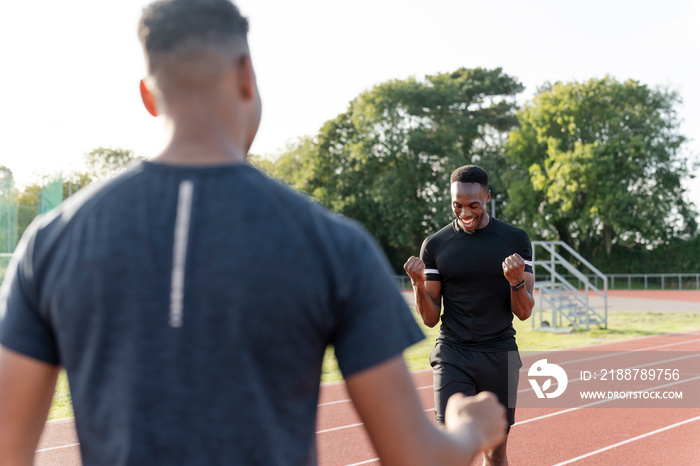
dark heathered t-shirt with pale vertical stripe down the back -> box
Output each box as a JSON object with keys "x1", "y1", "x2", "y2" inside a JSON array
[{"x1": 0, "y1": 162, "x2": 423, "y2": 465}]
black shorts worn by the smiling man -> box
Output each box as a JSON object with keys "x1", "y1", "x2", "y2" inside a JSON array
[{"x1": 430, "y1": 342, "x2": 522, "y2": 431}]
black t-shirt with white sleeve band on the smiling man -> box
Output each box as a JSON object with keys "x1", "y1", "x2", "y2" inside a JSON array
[{"x1": 421, "y1": 217, "x2": 532, "y2": 351}]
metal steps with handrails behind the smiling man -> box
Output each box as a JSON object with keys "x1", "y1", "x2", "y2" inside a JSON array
[{"x1": 532, "y1": 241, "x2": 608, "y2": 331}]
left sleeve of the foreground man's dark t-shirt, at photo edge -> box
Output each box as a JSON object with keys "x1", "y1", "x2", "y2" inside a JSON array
[{"x1": 0, "y1": 224, "x2": 59, "y2": 365}]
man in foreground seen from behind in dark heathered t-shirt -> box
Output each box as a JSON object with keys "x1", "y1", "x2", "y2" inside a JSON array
[{"x1": 0, "y1": 0, "x2": 505, "y2": 465}]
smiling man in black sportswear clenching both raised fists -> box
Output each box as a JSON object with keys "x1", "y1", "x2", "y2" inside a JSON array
[{"x1": 404, "y1": 165, "x2": 534, "y2": 465}]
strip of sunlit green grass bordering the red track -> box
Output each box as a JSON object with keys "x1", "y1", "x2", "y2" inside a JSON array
[{"x1": 49, "y1": 312, "x2": 700, "y2": 419}]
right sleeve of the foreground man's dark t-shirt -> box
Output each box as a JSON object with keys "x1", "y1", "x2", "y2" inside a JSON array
[{"x1": 332, "y1": 224, "x2": 425, "y2": 377}]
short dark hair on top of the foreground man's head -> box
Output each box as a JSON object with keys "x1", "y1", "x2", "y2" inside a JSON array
[{"x1": 138, "y1": 0, "x2": 248, "y2": 58}]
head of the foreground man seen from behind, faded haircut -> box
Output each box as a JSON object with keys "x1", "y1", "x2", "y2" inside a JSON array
[{"x1": 138, "y1": 0, "x2": 261, "y2": 158}]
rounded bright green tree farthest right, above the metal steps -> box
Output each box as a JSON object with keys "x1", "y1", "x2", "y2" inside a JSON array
[{"x1": 507, "y1": 76, "x2": 697, "y2": 257}]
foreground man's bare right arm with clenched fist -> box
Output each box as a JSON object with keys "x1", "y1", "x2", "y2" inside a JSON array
[{"x1": 346, "y1": 355, "x2": 507, "y2": 466}]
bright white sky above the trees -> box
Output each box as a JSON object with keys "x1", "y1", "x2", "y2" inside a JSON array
[{"x1": 0, "y1": 0, "x2": 700, "y2": 215}]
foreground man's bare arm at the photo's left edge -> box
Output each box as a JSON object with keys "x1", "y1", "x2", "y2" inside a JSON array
[{"x1": 0, "y1": 346, "x2": 59, "y2": 466}]
